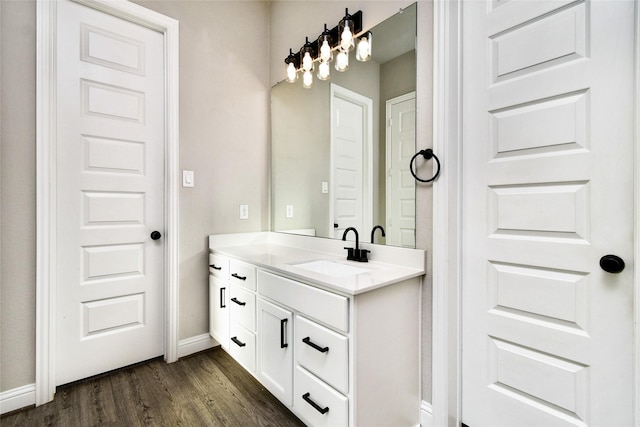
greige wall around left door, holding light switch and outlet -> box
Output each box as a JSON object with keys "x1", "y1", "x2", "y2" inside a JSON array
[{"x1": 0, "y1": 0, "x2": 269, "y2": 391}]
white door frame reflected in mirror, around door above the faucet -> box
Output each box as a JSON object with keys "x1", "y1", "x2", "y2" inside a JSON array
[{"x1": 329, "y1": 83, "x2": 377, "y2": 236}]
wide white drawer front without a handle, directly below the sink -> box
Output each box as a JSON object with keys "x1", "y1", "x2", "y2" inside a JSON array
[{"x1": 258, "y1": 270, "x2": 349, "y2": 332}]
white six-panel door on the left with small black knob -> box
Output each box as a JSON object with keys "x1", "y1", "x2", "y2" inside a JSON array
[{"x1": 55, "y1": 1, "x2": 164, "y2": 384}]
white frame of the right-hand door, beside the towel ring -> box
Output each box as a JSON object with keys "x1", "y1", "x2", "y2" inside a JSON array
[{"x1": 431, "y1": 0, "x2": 640, "y2": 426}]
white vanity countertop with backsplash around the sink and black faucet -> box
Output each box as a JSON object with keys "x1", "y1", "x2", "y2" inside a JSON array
[{"x1": 209, "y1": 233, "x2": 425, "y2": 295}]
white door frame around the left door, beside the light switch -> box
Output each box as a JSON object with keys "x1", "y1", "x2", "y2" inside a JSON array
[{"x1": 35, "y1": 0, "x2": 179, "y2": 405}]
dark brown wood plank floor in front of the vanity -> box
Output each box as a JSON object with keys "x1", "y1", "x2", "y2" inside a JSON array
[{"x1": 0, "y1": 347, "x2": 304, "y2": 427}]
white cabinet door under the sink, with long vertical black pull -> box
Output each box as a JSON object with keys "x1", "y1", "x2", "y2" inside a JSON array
[{"x1": 257, "y1": 298, "x2": 293, "y2": 407}]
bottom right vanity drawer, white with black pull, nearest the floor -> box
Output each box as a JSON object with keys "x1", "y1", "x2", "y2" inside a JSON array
[{"x1": 293, "y1": 366, "x2": 344, "y2": 427}]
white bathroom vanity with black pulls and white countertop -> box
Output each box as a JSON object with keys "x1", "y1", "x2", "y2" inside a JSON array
[{"x1": 211, "y1": 236, "x2": 424, "y2": 427}]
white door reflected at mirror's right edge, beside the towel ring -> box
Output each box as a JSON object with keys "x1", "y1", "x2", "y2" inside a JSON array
[{"x1": 386, "y1": 92, "x2": 416, "y2": 248}]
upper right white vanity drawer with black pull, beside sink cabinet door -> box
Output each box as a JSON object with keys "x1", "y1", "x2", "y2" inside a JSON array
[{"x1": 294, "y1": 316, "x2": 349, "y2": 393}]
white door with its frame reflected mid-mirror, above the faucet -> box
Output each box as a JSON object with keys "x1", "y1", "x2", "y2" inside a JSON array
[{"x1": 331, "y1": 84, "x2": 373, "y2": 239}]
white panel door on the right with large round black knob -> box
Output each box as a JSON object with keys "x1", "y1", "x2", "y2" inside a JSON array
[{"x1": 462, "y1": 1, "x2": 637, "y2": 427}]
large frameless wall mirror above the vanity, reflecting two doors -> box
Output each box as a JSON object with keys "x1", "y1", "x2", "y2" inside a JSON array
[{"x1": 271, "y1": 4, "x2": 416, "y2": 247}]
